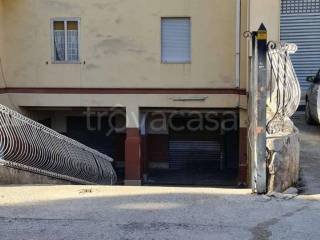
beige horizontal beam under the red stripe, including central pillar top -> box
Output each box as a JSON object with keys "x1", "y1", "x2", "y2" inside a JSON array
[{"x1": 9, "y1": 94, "x2": 242, "y2": 128}]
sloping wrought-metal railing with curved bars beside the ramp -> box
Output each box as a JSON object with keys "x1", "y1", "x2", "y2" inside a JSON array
[{"x1": 0, "y1": 104, "x2": 117, "y2": 185}]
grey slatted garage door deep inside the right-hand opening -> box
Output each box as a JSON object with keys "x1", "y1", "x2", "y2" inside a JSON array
[{"x1": 169, "y1": 118, "x2": 225, "y2": 171}]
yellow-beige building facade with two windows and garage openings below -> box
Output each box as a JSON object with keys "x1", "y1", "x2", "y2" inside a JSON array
[{"x1": 0, "y1": 0, "x2": 280, "y2": 185}]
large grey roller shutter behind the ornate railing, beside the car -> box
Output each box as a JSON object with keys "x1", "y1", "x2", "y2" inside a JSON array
[{"x1": 281, "y1": 0, "x2": 320, "y2": 90}]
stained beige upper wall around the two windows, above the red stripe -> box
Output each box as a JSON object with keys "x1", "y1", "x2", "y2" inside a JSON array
[{"x1": 4, "y1": 0, "x2": 236, "y2": 88}]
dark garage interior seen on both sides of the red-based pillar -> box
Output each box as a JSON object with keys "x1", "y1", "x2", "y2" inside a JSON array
[{"x1": 30, "y1": 109, "x2": 239, "y2": 187}]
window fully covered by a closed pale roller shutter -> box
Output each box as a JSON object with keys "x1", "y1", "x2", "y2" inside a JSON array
[{"x1": 161, "y1": 17, "x2": 191, "y2": 63}]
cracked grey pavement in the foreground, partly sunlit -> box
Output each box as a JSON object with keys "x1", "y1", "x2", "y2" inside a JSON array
[{"x1": 0, "y1": 114, "x2": 320, "y2": 240}]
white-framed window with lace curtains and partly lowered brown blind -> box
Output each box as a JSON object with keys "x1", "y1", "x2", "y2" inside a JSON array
[{"x1": 51, "y1": 18, "x2": 80, "y2": 63}]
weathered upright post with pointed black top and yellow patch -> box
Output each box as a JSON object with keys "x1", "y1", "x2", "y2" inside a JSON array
[{"x1": 249, "y1": 24, "x2": 268, "y2": 194}]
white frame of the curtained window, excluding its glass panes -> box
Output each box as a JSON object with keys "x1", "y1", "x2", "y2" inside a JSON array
[{"x1": 50, "y1": 17, "x2": 81, "y2": 64}]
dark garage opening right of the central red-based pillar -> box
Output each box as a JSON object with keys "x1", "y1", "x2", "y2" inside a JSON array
[{"x1": 146, "y1": 109, "x2": 239, "y2": 186}]
